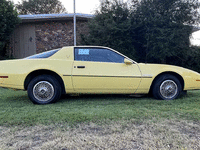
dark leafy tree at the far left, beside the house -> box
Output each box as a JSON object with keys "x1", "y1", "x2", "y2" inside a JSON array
[{"x1": 0, "y1": 0, "x2": 20, "y2": 57}]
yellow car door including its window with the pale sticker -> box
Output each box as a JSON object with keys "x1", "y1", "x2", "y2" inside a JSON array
[{"x1": 72, "y1": 47, "x2": 141, "y2": 93}]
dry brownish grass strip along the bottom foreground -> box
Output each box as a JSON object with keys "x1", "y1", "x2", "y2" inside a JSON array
[{"x1": 0, "y1": 120, "x2": 200, "y2": 150}]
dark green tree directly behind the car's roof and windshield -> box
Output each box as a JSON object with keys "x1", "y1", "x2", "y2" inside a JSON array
[{"x1": 81, "y1": 0, "x2": 134, "y2": 57}]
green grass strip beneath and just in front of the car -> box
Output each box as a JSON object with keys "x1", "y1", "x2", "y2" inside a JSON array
[{"x1": 0, "y1": 88, "x2": 200, "y2": 126}]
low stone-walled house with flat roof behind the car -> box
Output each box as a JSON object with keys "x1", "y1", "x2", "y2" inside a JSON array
[{"x1": 7, "y1": 14, "x2": 93, "y2": 58}]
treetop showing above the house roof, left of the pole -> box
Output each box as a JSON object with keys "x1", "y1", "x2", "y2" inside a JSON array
[{"x1": 16, "y1": 0, "x2": 66, "y2": 14}]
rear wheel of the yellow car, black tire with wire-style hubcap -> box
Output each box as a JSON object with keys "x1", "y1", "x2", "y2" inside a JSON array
[{"x1": 27, "y1": 75, "x2": 61, "y2": 104}]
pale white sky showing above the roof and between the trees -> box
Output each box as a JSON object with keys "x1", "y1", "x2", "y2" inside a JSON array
[{"x1": 12, "y1": 0, "x2": 200, "y2": 46}]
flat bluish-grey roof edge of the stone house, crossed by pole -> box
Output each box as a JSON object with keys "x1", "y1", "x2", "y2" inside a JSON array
[{"x1": 18, "y1": 13, "x2": 94, "y2": 22}]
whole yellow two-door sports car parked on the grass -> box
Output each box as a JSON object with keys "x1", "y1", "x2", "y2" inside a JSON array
[{"x1": 0, "y1": 46, "x2": 200, "y2": 104}]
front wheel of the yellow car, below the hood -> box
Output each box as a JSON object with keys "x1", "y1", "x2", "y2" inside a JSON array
[{"x1": 152, "y1": 74, "x2": 182, "y2": 100}]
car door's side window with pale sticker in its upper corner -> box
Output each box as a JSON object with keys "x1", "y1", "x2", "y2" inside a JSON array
[{"x1": 75, "y1": 48, "x2": 124, "y2": 63}]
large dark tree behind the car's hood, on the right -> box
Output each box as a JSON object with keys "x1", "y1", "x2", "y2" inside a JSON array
[{"x1": 131, "y1": 0, "x2": 199, "y2": 65}]
